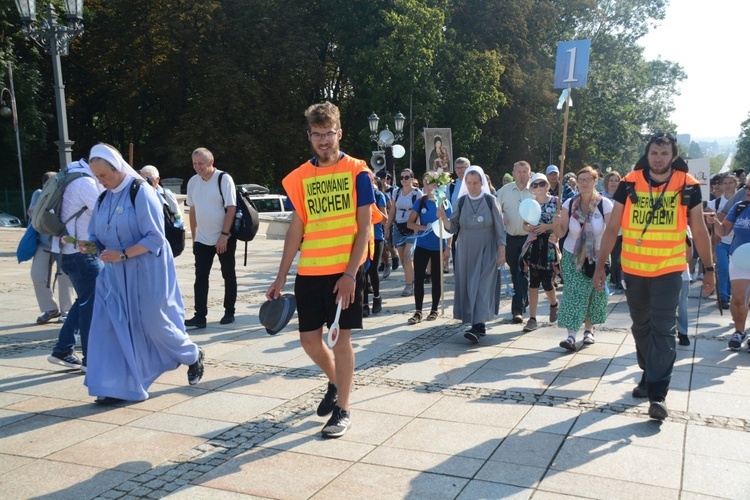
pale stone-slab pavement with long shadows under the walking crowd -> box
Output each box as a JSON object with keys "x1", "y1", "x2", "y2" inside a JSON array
[{"x1": 0, "y1": 229, "x2": 750, "y2": 499}]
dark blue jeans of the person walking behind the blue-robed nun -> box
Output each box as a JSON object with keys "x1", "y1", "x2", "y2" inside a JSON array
[{"x1": 53, "y1": 253, "x2": 104, "y2": 364}]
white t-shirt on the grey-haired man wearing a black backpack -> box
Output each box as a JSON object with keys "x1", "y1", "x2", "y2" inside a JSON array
[{"x1": 186, "y1": 170, "x2": 237, "y2": 246}]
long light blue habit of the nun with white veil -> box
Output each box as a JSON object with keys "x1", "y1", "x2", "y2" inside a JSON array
[{"x1": 85, "y1": 177, "x2": 198, "y2": 401}]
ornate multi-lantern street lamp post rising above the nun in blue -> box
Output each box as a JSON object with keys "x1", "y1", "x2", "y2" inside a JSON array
[{"x1": 15, "y1": 0, "x2": 83, "y2": 169}]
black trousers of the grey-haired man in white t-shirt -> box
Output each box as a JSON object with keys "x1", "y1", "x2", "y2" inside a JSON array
[{"x1": 193, "y1": 236, "x2": 237, "y2": 319}]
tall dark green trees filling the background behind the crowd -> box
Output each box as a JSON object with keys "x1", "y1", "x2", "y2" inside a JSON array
[{"x1": 0, "y1": 0, "x2": 685, "y2": 211}]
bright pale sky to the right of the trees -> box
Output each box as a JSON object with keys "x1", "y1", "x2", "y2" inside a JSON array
[{"x1": 641, "y1": 0, "x2": 750, "y2": 139}]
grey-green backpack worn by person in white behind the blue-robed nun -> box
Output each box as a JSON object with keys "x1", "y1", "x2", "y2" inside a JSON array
[{"x1": 31, "y1": 160, "x2": 91, "y2": 236}]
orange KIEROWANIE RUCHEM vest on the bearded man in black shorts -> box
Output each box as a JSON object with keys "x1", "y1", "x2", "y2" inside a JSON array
[{"x1": 282, "y1": 155, "x2": 382, "y2": 276}]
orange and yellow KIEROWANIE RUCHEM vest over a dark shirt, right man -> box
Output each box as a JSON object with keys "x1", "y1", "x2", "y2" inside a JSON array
[{"x1": 620, "y1": 170, "x2": 700, "y2": 277}]
